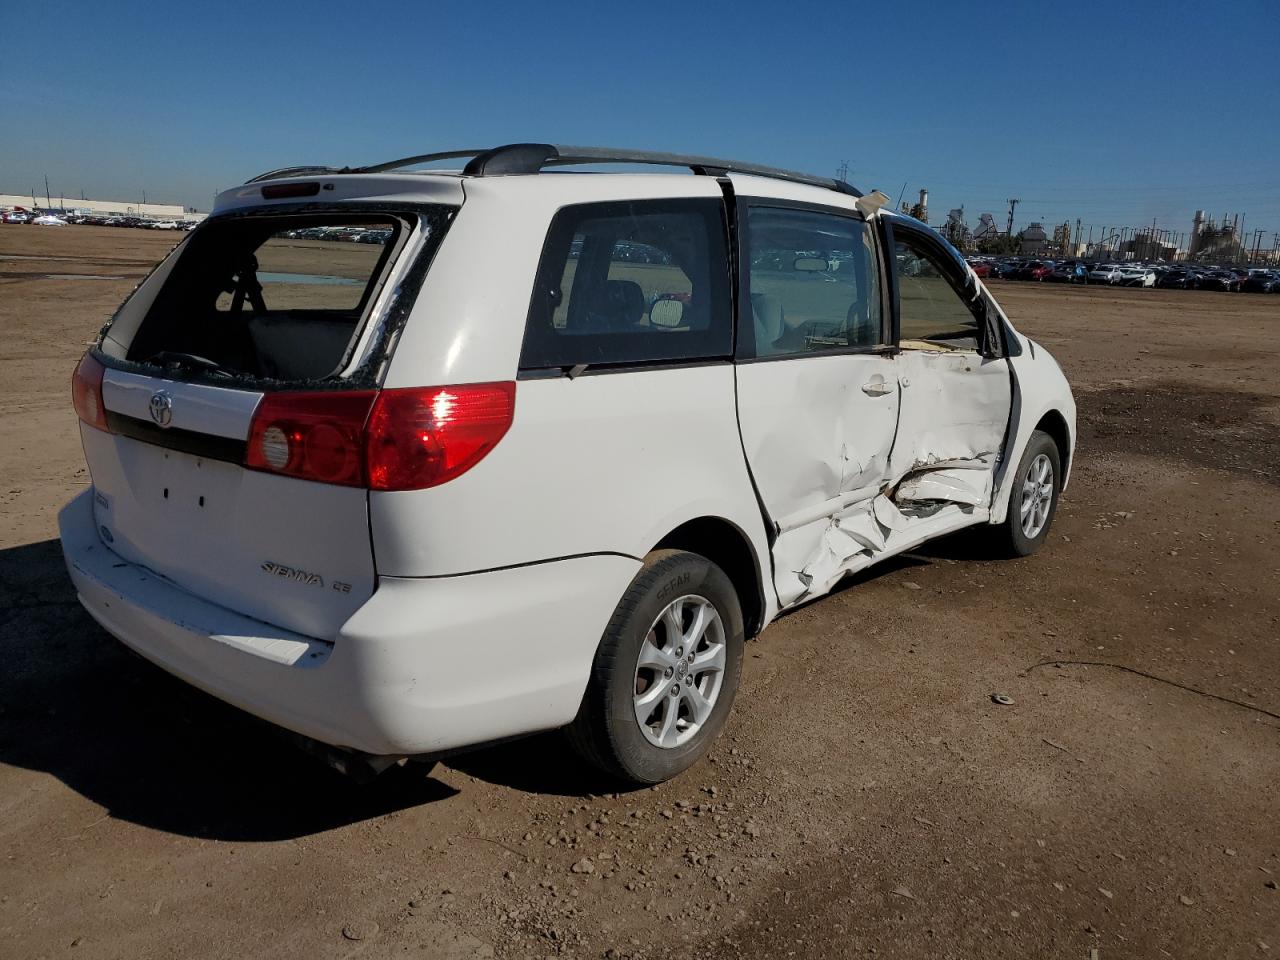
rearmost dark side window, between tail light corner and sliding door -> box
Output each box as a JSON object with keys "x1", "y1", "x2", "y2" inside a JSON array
[{"x1": 520, "y1": 200, "x2": 733, "y2": 370}]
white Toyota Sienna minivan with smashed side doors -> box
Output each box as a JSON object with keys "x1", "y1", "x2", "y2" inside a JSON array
[{"x1": 59, "y1": 143, "x2": 1075, "y2": 783}]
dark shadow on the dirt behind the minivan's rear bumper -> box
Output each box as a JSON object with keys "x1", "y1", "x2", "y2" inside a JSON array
[{"x1": 0, "y1": 540, "x2": 457, "y2": 841}]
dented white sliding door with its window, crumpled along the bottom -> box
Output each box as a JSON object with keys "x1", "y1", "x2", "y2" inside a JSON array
[{"x1": 737, "y1": 200, "x2": 899, "y2": 605}]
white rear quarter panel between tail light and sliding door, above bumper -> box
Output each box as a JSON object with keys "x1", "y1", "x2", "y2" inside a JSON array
[{"x1": 369, "y1": 364, "x2": 769, "y2": 582}]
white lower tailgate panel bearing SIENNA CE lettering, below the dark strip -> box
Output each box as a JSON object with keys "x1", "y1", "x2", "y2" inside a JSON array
[{"x1": 81, "y1": 425, "x2": 374, "y2": 640}]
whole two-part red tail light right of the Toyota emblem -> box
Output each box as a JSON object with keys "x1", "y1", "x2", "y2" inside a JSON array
[{"x1": 244, "y1": 381, "x2": 516, "y2": 490}]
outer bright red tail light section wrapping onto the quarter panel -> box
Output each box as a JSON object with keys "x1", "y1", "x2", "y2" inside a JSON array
[{"x1": 365, "y1": 381, "x2": 516, "y2": 490}]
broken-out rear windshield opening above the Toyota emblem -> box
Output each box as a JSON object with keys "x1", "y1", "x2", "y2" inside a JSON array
[{"x1": 127, "y1": 215, "x2": 403, "y2": 380}]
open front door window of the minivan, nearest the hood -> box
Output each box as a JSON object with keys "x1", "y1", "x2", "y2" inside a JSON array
[{"x1": 893, "y1": 234, "x2": 980, "y2": 349}]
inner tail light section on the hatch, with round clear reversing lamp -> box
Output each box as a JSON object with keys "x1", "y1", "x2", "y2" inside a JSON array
[{"x1": 244, "y1": 390, "x2": 378, "y2": 486}]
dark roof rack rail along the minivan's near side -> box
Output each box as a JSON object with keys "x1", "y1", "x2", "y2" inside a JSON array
[{"x1": 351, "y1": 143, "x2": 863, "y2": 197}]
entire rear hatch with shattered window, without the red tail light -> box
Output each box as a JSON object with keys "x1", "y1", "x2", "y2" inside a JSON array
[{"x1": 81, "y1": 204, "x2": 453, "y2": 639}]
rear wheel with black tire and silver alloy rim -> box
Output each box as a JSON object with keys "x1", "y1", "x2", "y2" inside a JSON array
[{"x1": 568, "y1": 550, "x2": 746, "y2": 785}]
